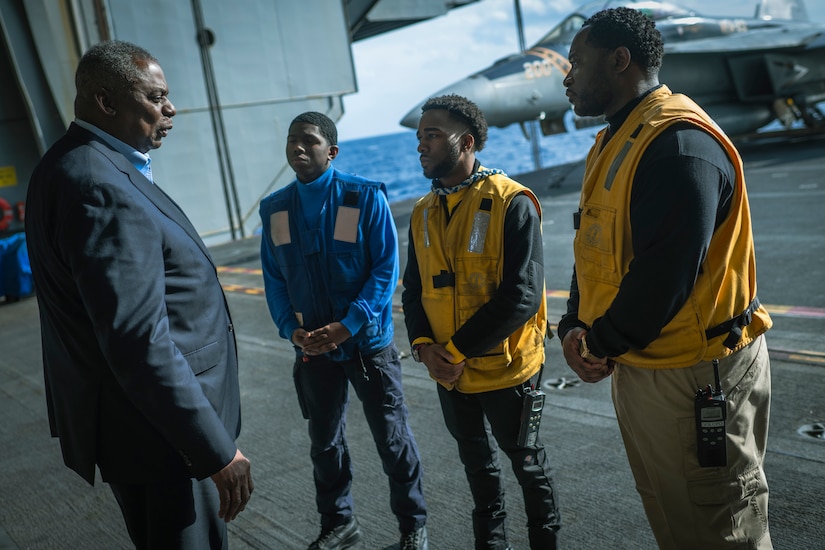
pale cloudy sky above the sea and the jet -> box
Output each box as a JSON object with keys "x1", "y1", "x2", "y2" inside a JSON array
[{"x1": 338, "y1": 0, "x2": 825, "y2": 141}]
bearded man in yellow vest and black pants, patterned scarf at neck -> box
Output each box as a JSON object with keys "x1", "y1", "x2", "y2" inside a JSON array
[{"x1": 402, "y1": 95, "x2": 559, "y2": 550}]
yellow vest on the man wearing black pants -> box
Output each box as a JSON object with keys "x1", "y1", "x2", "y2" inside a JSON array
[{"x1": 410, "y1": 171, "x2": 547, "y2": 393}]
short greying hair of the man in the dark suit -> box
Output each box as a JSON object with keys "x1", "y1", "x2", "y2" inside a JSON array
[{"x1": 75, "y1": 40, "x2": 160, "y2": 96}]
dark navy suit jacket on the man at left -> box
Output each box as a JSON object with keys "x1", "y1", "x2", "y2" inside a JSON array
[{"x1": 26, "y1": 124, "x2": 241, "y2": 483}]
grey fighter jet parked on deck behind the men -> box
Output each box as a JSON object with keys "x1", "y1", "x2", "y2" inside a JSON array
[{"x1": 401, "y1": 0, "x2": 825, "y2": 136}]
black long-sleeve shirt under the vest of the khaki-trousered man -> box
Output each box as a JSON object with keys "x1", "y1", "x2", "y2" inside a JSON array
[{"x1": 559, "y1": 89, "x2": 735, "y2": 357}]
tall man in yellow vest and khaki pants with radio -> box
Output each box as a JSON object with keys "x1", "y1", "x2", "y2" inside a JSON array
[{"x1": 559, "y1": 8, "x2": 772, "y2": 549}]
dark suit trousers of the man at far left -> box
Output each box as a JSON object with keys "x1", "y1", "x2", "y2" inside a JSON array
[{"x1": 109, "y1": 478, "x2": 229, "y2": 550}]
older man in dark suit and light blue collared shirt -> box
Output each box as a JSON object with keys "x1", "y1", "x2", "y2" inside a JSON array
[{"x1": 26, "y1": 41, "x2": 253, "y2": 549}]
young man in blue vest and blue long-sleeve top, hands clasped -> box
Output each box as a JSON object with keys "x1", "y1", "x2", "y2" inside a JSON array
[{"x1": 260, "y1": 112, "x2": 427, "y2": 549}]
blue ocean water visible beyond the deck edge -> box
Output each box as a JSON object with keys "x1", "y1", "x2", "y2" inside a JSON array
[{"x1": 333, "y1": 124, "x2": 600, "y2": 203}]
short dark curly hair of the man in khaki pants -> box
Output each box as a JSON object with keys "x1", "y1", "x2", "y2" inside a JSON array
[{"x1": 582, "y1": 7, "x2": 665, "y2": 72}]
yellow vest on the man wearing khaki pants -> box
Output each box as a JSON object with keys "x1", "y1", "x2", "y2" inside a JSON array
[{"x1": 573, "y1": 86, "x2": 772, "y2": 369}]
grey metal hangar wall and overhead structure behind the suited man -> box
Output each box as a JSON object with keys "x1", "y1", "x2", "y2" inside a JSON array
[{"x1": 0, "y1": 0, "x2": 476, "y2": 244}]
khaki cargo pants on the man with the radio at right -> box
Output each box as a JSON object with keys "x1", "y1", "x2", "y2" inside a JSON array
[{"x1": 612, "y1": 335, "x2": 772, "y2": 550}]
